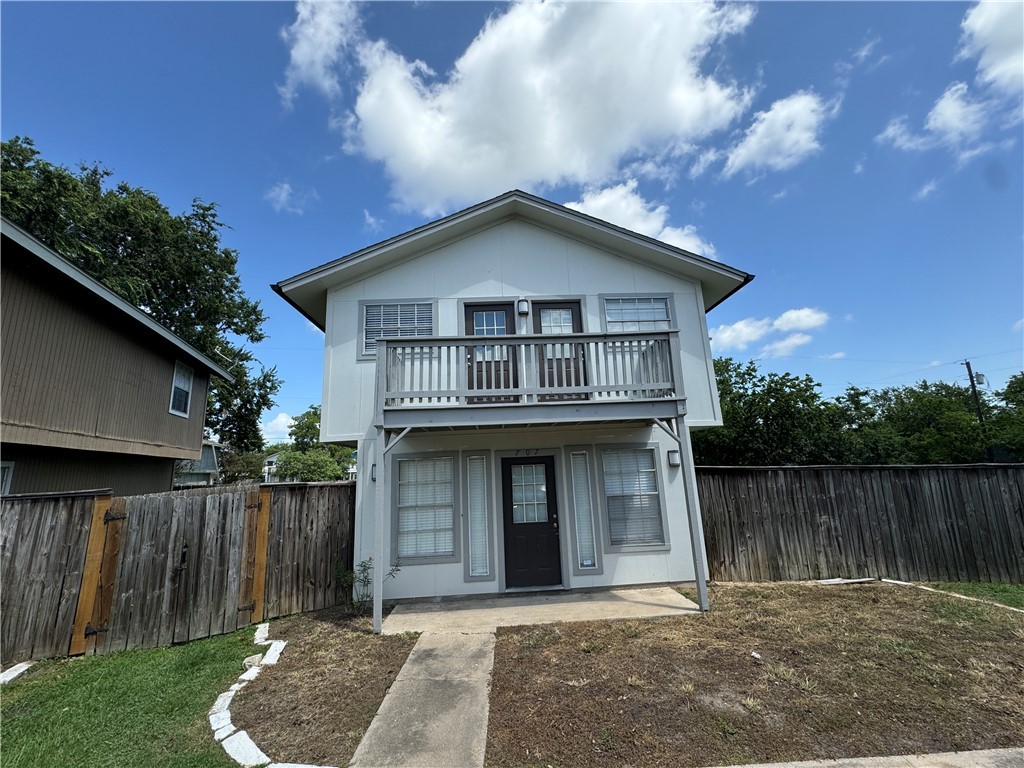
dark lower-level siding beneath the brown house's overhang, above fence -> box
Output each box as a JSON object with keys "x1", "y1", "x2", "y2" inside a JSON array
[{"x1": 0, "y1": 442, "x2": 174, "y2": 496}]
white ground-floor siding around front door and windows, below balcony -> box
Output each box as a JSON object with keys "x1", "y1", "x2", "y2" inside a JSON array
[{"x1": 355, "y1": 425, "x2": 703, "y2": 599}]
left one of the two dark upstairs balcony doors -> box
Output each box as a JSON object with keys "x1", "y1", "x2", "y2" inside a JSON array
[{"x1": 466, "y1": 304, "x2": 519, "y2": 404}]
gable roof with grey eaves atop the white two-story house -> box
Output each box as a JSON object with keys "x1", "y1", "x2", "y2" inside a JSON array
[{"x1": 270, "y1": 189, "x2": 754, "y2": 330}]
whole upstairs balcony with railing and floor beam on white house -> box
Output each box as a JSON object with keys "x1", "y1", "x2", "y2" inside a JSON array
[{"x1": 376, "y1": 331, "x2": 686, "y2": 430}]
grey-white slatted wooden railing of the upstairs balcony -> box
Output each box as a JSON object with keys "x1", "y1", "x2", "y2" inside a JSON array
[{"x1": 378, "y1": 331, "x2": 682, "y2": 410}]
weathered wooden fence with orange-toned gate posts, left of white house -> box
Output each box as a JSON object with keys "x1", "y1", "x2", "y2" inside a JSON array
[{"x1": 0, "y1": 483, "x2": 354, "y2": 667}]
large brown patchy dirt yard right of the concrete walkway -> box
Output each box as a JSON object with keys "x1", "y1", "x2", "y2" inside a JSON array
[{"x1": 486, "y1": 584, "x2": 1024, "y2": 766}]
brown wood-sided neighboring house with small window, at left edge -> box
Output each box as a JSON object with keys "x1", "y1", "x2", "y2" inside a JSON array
[{"x1": 0, "y1": 219, "x2": 230, "y2": 496}]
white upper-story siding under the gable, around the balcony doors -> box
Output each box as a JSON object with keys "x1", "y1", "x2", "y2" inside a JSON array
[{"x1": 322, "y1": 220, "x2": 721, "y2": 442}]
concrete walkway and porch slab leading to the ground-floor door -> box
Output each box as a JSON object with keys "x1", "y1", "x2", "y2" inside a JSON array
[{"x1": 349, "y1": 587, "x2": 698, "y2": 768}]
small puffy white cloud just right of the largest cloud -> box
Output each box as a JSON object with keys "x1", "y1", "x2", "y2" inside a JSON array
[{"x1": 722, "y1": 91, "x2": 829, "y2": 178}]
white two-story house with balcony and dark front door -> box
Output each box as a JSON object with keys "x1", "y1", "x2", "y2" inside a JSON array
[{"x1": 273, "y1": 191, "x2": 752, "y2": 624}]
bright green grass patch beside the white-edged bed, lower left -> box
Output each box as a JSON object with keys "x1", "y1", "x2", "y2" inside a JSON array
[{"x1": 0, "y1": 629, "x2": 254, "y2": 768}]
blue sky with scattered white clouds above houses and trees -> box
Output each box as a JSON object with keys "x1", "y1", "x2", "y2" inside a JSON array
[{"x1": 0, "y1": 2, "x2": 1024, "y2": 438}]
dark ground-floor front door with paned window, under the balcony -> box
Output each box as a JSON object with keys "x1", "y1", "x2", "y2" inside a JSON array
[{"x1": 502, "y1": 456, "x2": 562, "y2": 587}]
